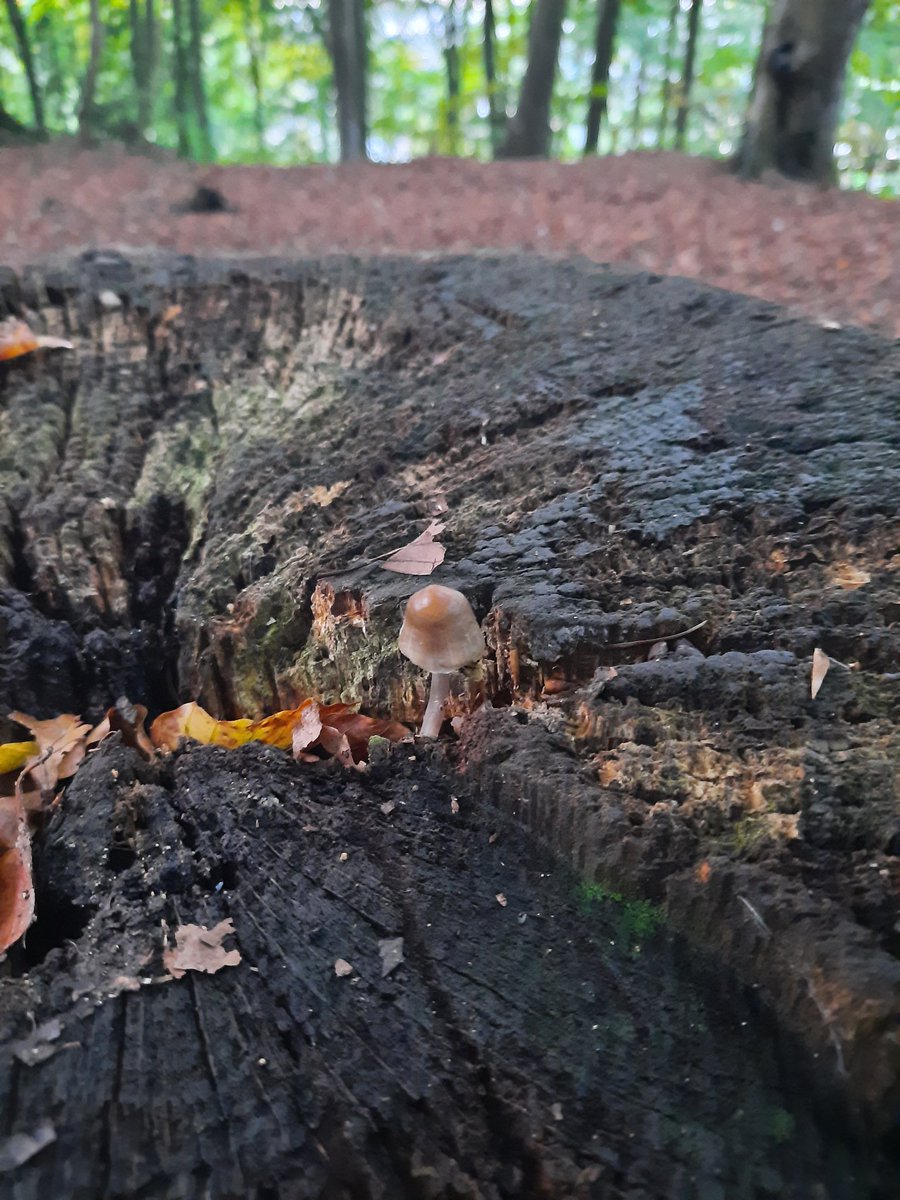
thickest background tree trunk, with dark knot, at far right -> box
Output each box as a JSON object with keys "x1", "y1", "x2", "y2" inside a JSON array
[{"x1": 738, "y1": 0, "x2": 869, "y2": 184}]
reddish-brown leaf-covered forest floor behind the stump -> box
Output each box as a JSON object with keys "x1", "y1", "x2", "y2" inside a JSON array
[{"x1": 0, "y1": 144, "x2": 900, "y2": 335}]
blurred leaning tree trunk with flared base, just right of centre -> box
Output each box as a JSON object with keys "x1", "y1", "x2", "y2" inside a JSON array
[{"x1": 498, "y1": 0, "x2": 565, "y2": 158}]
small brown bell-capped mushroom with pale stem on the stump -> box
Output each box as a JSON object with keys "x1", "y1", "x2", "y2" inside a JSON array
[{"x1": 398, "y1": 583, "x2": 485, "y2": 738}]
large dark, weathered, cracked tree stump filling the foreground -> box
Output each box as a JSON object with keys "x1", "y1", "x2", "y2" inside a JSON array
[{"x1": 0, "y1": 253, "x2": 900, "y2": 1200}]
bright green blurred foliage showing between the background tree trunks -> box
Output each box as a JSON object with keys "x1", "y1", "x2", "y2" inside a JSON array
[{"x1": 0, "y1": 0, "x2": 900, "y2": 194}]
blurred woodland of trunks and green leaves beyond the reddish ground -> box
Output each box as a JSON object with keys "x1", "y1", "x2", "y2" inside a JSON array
[{"x1": 0, "y1": 0, "x2": 900, "y2": 196}]
